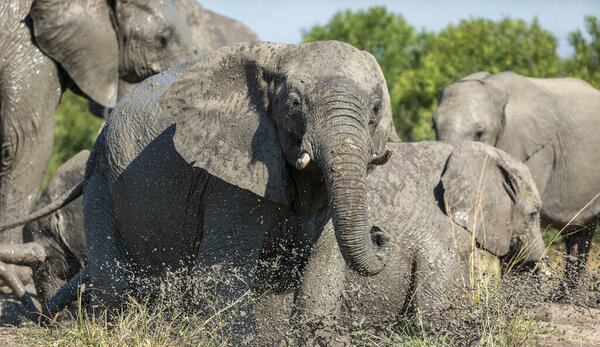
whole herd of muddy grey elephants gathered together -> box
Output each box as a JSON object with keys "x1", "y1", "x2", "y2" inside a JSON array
[{"x1": 0, "y1": 0, "x2": 600, "y2": 342}]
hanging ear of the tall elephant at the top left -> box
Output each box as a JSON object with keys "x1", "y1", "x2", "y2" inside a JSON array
[{"x1": 31, "y1": 0, "x2": 120, "y2": 107}]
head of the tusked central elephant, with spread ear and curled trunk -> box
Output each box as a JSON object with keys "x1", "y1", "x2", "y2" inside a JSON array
[{"x1": 159, "y1": 41, "x2": 393, "y2": 275}]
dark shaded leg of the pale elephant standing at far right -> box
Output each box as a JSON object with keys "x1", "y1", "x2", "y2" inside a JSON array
[{"x1": 565, "y1": 223, "x2": 597, "y2": 289}]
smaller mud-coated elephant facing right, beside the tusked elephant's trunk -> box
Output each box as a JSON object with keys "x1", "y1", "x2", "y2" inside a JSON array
[{"x1": 256, "y1": 142, "x2": 544, "y2": 342}]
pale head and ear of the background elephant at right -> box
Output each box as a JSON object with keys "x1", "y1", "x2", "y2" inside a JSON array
[{"x1": 433, "y1": 72, "x2": 558, "y2": 161}]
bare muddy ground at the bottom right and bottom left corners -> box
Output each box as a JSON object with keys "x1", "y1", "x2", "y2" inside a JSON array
[{"x1": 0, "y1": 243, "x2": 600, "y2": 346}]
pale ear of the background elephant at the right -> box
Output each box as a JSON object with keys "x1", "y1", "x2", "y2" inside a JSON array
[{"x1": 486, "y1": 72, "x2": 559, "y2": 161}]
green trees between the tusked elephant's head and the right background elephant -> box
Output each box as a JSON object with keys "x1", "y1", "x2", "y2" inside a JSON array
[{"x1": 304, "y1": 11, "x2": 559, "y2": 141}]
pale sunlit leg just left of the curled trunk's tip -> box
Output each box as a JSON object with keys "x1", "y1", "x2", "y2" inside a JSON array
[{"x1": 292, "y1": 219, "x2": 346, "y2": 344}]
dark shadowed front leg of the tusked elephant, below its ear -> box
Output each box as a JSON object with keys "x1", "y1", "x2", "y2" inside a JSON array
[{"x1": 196, "y1": 188, "x2": 278, "y2": 343}]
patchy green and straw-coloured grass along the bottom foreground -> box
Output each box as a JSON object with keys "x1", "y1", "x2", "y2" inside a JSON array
[{"x1": 0, "y1": 235, "x2": 584, "y2": 346}]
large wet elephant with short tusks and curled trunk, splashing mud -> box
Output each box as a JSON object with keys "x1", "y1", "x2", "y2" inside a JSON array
[{"x1": 4, "y1": 41, "x2": 393, "y2": 338}]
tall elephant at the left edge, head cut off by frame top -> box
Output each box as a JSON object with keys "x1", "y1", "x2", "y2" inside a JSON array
[{"x1": 0, "y1": 0, "x2": 197, "y2": 300}]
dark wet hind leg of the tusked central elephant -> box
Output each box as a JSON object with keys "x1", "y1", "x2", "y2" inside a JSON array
[{"x1": 83, "y1": 174, "x2": 133, "y2": 314}]
